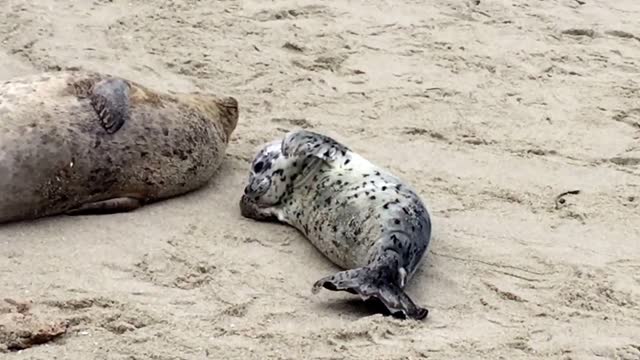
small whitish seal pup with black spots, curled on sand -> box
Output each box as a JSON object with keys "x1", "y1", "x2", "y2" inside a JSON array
[{"x1": 240, "y1": 130, "x2": 431, "y2": 319}]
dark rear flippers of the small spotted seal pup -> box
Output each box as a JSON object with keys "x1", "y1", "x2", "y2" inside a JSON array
[{"x1": 311, "y1": 267, "x2": 429, "y2": 320}]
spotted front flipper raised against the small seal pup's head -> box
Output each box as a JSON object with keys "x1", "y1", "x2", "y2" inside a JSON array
[{"x1": 282, "y1": 130, "x2": 349, "y2": 162}]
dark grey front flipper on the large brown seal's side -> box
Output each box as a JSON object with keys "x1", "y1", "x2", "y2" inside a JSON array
[{"x1": 89, "y1": 78, "x2": 129, "y2": 134}]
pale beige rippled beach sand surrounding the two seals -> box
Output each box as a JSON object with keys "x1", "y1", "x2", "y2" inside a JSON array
[{"x1": 0, "y1": 0, "x2": 640, "y2": 360}]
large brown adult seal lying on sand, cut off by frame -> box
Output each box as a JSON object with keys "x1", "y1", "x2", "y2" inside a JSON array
[{"x1": 0, "y1": 71, "x2": 238, "y2": 223}]
